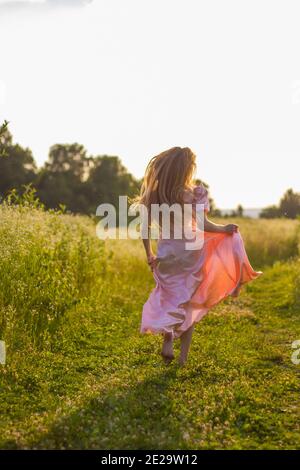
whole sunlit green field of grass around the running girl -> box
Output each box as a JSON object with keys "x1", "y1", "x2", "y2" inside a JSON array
[{"x1": 0, "y1": 206, "x2": 300, "y2": 449}]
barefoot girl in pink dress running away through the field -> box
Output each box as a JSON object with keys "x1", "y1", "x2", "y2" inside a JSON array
[{"x1": 138, "y1": 147, "x2": 262, "y2": 365}]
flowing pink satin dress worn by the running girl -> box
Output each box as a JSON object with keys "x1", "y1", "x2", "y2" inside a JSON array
[{"x1": 140, "y1": 185, "x2": 262, "y2": 338}]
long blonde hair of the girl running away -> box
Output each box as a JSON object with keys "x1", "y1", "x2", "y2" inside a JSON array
[{"x1": 136, "y1": 147, "x2": 196, "y2": 210}]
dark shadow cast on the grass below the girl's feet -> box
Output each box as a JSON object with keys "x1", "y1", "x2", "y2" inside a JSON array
[{"x1": 30, "y1": 364, "x2": 186, "y2": 449}]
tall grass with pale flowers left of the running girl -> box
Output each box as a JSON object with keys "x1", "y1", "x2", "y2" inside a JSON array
[{"x1": 0, "y1": 204, "x2": 105, "y2": 349}]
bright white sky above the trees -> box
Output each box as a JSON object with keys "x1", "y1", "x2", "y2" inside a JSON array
[{"x1": 0, "y1": 0, "x2": 300, "y2": 208}]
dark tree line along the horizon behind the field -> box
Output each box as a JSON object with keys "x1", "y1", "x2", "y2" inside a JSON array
[{"x1": 0, "y1": 122, "x2": 300, "y2": 219}]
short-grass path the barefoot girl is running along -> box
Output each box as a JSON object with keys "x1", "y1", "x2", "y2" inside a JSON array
[{"x1": 0, "y1": 246, "x2": 300, "y2": 449}]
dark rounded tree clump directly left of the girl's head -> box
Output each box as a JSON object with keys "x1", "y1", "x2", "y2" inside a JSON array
[{"x1": 36, "y1": 143, "x2": 139, "y2": 214}]
